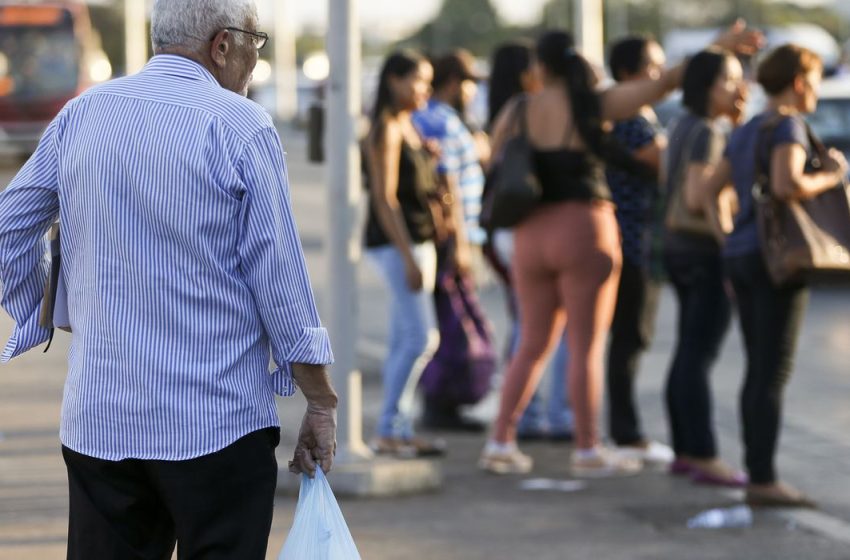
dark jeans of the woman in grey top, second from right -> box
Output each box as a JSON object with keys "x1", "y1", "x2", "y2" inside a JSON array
[{"x1": 664, "y1": 252, "x2": 732, "y2": 459}]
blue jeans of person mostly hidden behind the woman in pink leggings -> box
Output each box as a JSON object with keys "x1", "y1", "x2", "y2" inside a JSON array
[{"x1": 493, "y1": 230, "x2": 573, "y2": 435}]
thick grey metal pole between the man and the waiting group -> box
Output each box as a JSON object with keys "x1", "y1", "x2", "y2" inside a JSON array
[{"x1": 325, "y1": 0, "x2": 372, "y2": 462}]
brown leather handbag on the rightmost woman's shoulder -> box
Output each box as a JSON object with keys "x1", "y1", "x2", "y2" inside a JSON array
[{"x1": 753, "y1": 118, "x2": 850, "y2": 285}]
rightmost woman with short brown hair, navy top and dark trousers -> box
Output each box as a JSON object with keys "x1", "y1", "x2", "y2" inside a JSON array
[{"x1": 701, "y1": 45, "x2": 848, "y2": 507}]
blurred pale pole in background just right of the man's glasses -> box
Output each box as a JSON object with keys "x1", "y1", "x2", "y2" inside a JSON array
[{"x1": 272, "y1": 0, "x2": 298, "y2": 121}]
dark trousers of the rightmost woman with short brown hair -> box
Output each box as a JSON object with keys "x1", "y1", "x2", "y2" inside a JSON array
[{"x1": 726, "y1": 253, "x2": 809, "y2": 484}]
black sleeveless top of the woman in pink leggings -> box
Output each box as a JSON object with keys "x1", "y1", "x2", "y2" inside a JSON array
[{"x1": 533, "y1": 148, "x2": 612, "y2": 204}]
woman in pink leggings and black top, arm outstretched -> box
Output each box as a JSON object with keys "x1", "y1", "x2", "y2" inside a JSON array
[{"x1": 479, "y1": 26, "x2": 750, "y2": 476}]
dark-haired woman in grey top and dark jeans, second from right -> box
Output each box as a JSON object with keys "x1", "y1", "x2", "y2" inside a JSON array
[{"x1": 664, "y1": 49, "x2": 747, "y2": 486}]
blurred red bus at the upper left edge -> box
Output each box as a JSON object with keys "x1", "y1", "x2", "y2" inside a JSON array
[{"x1": 0, "y1": 0, "x2": 109, "y2": 155}]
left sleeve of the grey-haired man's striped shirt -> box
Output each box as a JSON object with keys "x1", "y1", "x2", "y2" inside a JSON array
[{"x1": 0, "y1": 116, "x2": 64, "y2": 363}]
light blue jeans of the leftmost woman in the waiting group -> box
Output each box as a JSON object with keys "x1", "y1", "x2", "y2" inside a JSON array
[{"x1": 367, "y1": 242, "x2": 439, "y2": 439}]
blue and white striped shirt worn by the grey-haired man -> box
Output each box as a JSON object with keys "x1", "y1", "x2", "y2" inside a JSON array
[{"x1": 0, "y1": 55, "x2": 333, "y2": 460}]
